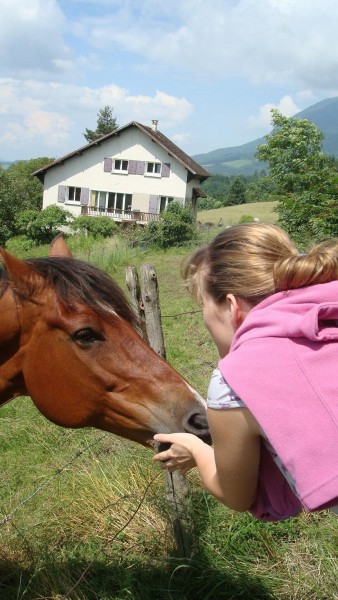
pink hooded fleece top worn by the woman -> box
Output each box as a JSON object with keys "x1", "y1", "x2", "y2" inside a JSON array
[{"x1": 219, "y1": 281, "x2": 338, "y2": 520}]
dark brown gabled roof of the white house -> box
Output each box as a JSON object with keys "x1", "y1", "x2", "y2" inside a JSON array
[{"x1": 32, "y1": 121, "x2": 210, "y2": 181}]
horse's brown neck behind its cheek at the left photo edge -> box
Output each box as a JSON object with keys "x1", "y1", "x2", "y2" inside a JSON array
[{"x1": 0, "y1": 288, "x2": 25, "y2": 405}]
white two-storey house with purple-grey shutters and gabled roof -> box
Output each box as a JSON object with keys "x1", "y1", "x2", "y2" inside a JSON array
[{"x1": 33, "y1": 121, "x2": 210, "y2": 223}]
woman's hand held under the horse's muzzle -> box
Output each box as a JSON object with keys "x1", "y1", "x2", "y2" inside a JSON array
[{"x1": 153, "y1": 433, "x2": 206, "y2": 475}]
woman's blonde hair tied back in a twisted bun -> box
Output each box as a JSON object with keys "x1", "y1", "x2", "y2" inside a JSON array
[{"x1": 182, "y1": 223, "x2": 338, "y2": 306}]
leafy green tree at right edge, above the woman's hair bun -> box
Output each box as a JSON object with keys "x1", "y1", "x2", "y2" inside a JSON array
[{"x1": 256, "y1": 109, "x2": 338, "y2": 245}]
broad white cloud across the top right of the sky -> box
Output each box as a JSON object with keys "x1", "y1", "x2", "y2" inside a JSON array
[{"x1": 72, "y1": 0, "x2": 338, "y2": 89}]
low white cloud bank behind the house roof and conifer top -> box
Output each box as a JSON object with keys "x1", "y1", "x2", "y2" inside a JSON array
[{"x1": 0, "y1": 78, "x2": 192, "y2": 156}]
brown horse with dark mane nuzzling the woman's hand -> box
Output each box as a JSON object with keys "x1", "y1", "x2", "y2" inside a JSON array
[{"x1": 0, "y1": 237, "x2": 208, "y2": 445}]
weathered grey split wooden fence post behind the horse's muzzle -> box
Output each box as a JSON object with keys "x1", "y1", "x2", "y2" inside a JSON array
[{"x1": 126, "y1": 264, "x2": 193, "y2": 558}]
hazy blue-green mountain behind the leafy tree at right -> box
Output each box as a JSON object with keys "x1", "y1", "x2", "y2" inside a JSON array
[{"x1": 192, "y1": 97, "x2": 338, "y2": 175}]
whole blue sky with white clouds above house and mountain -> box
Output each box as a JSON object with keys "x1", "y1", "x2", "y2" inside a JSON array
[{"x1": 0, "y1": 0, "x2": 338, "y2": 161}]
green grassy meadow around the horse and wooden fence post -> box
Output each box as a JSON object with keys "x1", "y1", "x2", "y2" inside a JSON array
[{"x1": 0, "y1": 203, "x2": 338, "y2": 600}]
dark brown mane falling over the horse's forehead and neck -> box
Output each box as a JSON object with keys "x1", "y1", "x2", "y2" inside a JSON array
[{"x1": 0, "y1": 256, "x2": 136, "y2": 325}]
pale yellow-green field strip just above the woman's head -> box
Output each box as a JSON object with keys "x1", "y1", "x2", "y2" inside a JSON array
[{"x1": 197, "y1": 202, "x2": 278, "y2": 226}]
